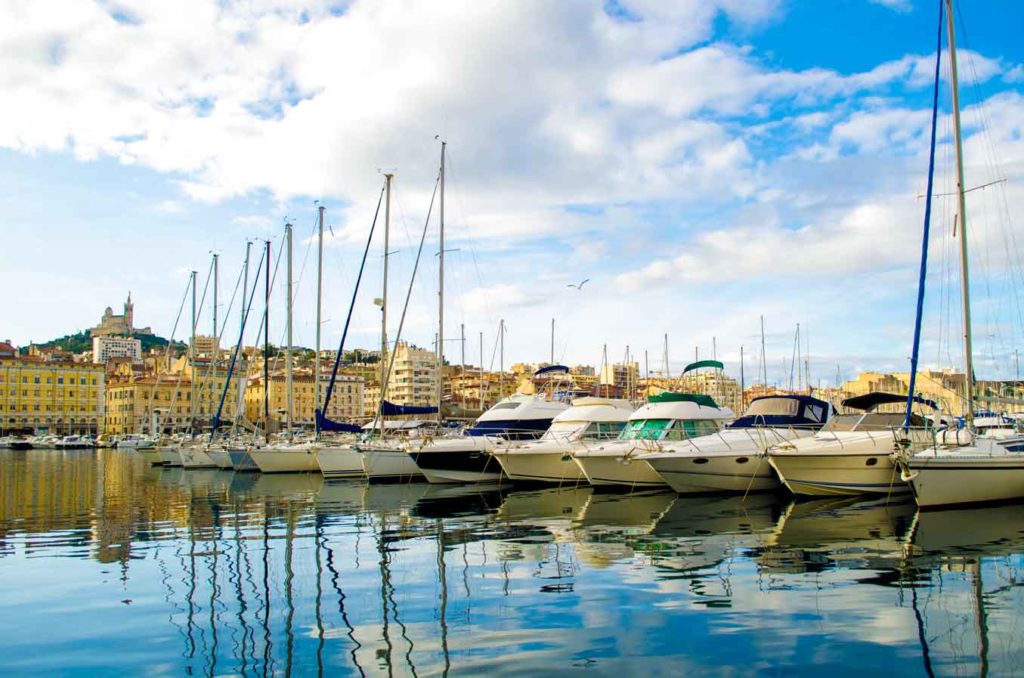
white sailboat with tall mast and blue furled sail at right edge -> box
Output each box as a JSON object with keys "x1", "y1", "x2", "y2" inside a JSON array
[{"x1": 895, "y1": 0, "x2": 1024, "y2": 508}]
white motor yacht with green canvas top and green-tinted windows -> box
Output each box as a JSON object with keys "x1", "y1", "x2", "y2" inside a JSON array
[{"x1": 572, "y1": 392, "x2": 735, "y2": 488}]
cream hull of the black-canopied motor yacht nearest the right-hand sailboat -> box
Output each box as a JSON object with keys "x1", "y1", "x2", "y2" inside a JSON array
[{"x1": 768, "y1": 451, "x2": 910, "y2": 497}]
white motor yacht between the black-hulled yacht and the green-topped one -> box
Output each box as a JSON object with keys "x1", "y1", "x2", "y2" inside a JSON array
[{"x1": 490, "y1": 397, "x2": 634, "y2": 483}]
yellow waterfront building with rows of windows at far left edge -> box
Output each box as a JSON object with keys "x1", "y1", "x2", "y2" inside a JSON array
[{"x1": 0, "y1": 350, "x2": 104, "y2": 435}]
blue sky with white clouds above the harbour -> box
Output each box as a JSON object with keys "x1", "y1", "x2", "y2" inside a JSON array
[{"x1": 0, "y1": 0, "x2": 1024, "y2": 383}]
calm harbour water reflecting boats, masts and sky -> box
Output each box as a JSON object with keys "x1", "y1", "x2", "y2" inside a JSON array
[{"x1": 0, "y1": 450, "x2": 1024, "y2": 675}]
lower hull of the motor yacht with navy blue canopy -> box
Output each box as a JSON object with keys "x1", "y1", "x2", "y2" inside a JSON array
[{"x1": 644, "y1": 454, "x2": 782, "y2": 495}]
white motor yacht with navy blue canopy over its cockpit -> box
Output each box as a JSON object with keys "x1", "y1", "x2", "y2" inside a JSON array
[{"x1": 637, "y1": 395, "x2": 833, "y2": 495}]
